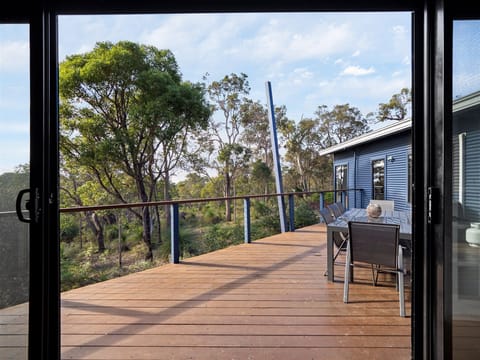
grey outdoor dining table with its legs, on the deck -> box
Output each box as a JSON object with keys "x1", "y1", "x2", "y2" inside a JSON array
[{"x1": 327, "y1": 208, "x2": 412, "y2": 281}]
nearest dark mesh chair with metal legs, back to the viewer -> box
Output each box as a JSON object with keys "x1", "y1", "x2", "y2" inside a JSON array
[{"x1": 343, "y1": 221, "x2": 405, "y2": 316}]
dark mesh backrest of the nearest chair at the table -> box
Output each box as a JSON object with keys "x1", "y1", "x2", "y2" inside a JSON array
[{"x1": 348, "y1": 221, "x2": 400, "y2": 268}]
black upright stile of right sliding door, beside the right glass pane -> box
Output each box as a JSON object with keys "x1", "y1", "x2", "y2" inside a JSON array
[{"x1": 423, "y1": 0, "x2": 480, "y2": 359}]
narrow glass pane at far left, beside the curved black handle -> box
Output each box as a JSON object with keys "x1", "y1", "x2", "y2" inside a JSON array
[{"x1": 0, "y1": 24, "x2": 30, "y2": 359}]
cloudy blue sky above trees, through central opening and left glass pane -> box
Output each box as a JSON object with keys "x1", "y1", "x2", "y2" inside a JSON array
[{"x1": 0, "y1": 12, "x2": 411, "y2": 174}]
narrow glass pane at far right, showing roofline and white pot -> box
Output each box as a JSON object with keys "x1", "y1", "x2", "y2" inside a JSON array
[{"x1": 452, "y1": 21, "x2": 480, "y2": 359}]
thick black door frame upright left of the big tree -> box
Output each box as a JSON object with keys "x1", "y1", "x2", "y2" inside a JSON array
[{"x1": 28, "y1": 5, "x2": 60, "y2": 359}]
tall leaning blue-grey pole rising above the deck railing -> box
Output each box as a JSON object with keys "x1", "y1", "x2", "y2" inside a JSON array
[{"x1": 265, "y1": 81, "x2": 287, "y2": 233}]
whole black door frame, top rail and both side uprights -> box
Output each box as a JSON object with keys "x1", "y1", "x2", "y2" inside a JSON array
[{"x1": 10, "y1": 0, "x2": 471, "y2": 359}]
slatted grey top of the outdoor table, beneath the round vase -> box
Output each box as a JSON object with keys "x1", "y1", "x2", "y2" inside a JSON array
[{"x1": 327, "y1": 208, "x2": 412, "y2": 240}]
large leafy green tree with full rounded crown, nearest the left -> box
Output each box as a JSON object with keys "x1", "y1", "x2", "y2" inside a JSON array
[{"x1": 59, "y1": 41, "x2": 209, "y2": 259}]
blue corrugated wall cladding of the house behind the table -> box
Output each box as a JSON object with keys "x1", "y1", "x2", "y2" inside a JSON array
[{"x1": 334, "y1": 130, "x2": 411, "y2": 210}]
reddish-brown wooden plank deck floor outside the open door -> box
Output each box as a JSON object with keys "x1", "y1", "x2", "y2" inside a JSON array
[{"x1": 61, "y1": 225, "x2": 411, "y2": 360}]
